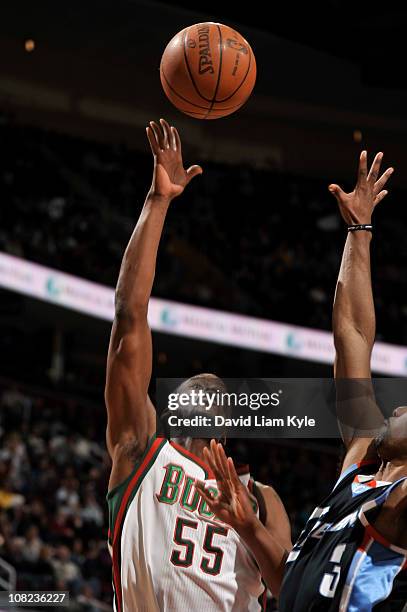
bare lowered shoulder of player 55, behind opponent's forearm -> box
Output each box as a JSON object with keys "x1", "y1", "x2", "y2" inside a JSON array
[{"x1": 252, "y1": 482, "x2": 293, "y2": 551}]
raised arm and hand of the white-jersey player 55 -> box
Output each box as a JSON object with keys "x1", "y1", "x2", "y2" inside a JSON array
[{"x1": 105, "y1": 119, "x2": 202, "y2": 486}]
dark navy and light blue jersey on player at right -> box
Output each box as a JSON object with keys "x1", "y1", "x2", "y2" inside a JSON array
[{"x1": 279, "y1": 464, "x2": 407, "y2": 612}]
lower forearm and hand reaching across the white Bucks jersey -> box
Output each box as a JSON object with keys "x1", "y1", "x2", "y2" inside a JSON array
[{"x1": 195, "y1": 440, "x2": 291, "y2": 597}]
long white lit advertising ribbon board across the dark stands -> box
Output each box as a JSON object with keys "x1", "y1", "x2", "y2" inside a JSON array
[{"x1": 0, "y1": 253, "x2": 407, "y2": 376}]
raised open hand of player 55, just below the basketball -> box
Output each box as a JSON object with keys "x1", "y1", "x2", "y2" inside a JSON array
[{"x1": 146, "y1": 119, "x2": 202, "y2": 200}]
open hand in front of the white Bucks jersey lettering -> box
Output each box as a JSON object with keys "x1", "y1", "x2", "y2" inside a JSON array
[{"x1": 195, "y1": 440, "x2": 258, "y2": 534}]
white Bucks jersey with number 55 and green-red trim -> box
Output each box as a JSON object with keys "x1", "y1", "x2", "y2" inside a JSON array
[{"x1": 108, "y1": 438, "x2": 264, "y2": 612}]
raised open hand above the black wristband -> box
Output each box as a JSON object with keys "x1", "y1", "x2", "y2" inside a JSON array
[{"x1": 328, "y1": 151, "x2": 394, "y2": 225}]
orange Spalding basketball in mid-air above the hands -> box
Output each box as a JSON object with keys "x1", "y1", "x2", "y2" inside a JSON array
[{"x1": 160, "y1": 22, "x2": 256, "y2": 119}]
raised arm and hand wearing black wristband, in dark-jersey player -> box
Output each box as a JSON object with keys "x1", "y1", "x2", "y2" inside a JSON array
[{"x1": 329, "y1": 151, "x2": 393, "y2": 469}]
